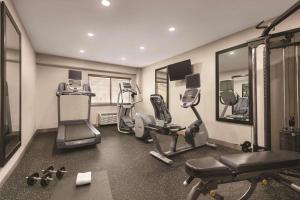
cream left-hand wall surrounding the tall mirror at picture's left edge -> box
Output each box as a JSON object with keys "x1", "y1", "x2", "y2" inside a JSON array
[{"x1": 0, "y1": 0, "x2": 36, "y2": 185}]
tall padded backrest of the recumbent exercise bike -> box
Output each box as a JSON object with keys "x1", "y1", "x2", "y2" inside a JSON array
[{"x1": 150, "y1": 94, "x2": 172, "y2": 124}]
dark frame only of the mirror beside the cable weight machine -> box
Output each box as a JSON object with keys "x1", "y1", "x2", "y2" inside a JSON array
[{"x1": 216, "y1": 43, "x2": 253, "y2": 125}]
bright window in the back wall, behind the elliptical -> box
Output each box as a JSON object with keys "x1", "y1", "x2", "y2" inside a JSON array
[{"x1": 89, "y1": 75, "x2": 130, "y2": 105}]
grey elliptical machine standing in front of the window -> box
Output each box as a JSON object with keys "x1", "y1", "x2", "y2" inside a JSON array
[{"x1": 117, "y1": 82, "x2": 155, "y2": 142}]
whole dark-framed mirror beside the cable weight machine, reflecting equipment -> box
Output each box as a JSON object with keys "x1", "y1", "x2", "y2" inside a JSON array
[{"x1": 216, "y1": 44, "x2": 252, "y2": 124}]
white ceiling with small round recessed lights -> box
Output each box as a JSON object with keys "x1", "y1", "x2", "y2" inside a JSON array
[{"x1": 13, "y1": 0, "x2": 297, "y2": 67}]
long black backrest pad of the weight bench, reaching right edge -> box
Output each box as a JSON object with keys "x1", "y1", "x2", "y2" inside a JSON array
[{"x1": 220, "y1": 151, "x2": 300, "y2": 173}]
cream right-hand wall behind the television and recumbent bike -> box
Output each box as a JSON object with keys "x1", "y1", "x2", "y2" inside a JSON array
[{"x1": 141, "y1": 12, "x2": 300, "y2": 147}]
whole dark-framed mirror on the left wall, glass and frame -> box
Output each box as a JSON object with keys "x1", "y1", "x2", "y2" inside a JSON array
[{"x1": 0, "y1": 2, "x2": 21, "y2": 166}]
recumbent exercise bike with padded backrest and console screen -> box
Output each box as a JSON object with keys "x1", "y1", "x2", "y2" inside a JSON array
[{"x1": 147, "y1": 74, "x2": 216, "y2": 164}]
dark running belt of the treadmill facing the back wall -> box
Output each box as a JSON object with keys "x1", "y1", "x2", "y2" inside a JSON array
[{"x1": 65, "y1": 123, "x2": 95, "y2": 141}]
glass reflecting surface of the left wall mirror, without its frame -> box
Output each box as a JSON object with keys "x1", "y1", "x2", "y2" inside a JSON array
[{"x1": 3, "y1": 10, "x2": 21, "y2": 159}]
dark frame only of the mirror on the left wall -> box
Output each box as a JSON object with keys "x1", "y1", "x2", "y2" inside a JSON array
[{"x1": 0, "y1": 2, "x2": 22, "y2": 167}]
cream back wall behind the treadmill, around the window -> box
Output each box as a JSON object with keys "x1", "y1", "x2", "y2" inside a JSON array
[{"x1": 36, "y1": 54, "x2": 140, "y2": 129}]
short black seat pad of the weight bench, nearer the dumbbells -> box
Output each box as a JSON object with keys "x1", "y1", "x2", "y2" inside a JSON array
[{"x1": 185, "y1": 157, "x2": 231, "y2": 178}]
